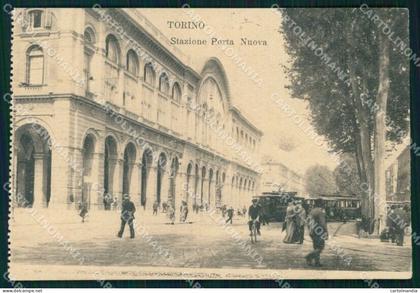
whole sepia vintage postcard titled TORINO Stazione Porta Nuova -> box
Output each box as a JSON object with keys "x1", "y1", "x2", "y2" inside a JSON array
[{"x1": 8, "y1": 5, "x2": 412, "y2": 280}]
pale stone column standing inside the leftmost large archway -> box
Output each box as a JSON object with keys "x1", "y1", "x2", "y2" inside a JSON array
[{"x1": 33, "y1": 153, "x2": 47, "y2": 208}]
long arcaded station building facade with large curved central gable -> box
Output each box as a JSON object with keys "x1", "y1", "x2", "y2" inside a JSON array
[{"x1": 12, "y1": 8, "x2": 262, "y2": 209}]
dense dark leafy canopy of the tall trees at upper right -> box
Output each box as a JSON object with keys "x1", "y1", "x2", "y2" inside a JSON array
[{"x1": 282, "y1": 8, "x2": 409, "y2": 153}]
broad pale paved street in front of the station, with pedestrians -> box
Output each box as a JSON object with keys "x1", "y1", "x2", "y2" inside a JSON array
[{"x1": 11, "y1": 209, "x2": 411, "y2": 277}]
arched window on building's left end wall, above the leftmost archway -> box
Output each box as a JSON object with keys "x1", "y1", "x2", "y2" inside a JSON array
[{"x1": 26, "y1": 45, "x2": 44, "y2": 85}]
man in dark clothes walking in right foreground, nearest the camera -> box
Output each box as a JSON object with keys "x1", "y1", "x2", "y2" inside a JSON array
[{"x1": 305, "y1": 198, "x2": 328, "y2": 267}]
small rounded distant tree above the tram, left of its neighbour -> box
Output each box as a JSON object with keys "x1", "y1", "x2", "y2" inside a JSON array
[{"x1": 304, "y1": 165, "x2": 337, "y2": 196}]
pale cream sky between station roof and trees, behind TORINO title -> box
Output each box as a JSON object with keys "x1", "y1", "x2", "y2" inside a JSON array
[{"x1": 138, "y1": 9, "x2": 336, "y2": 175}]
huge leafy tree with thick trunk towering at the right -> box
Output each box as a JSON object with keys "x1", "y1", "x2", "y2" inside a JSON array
[{"x1": 281, "y1": 8, "x2": 409, "y2": 229}]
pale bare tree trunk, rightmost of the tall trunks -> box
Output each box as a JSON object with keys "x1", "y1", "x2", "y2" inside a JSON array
[{"x1": 374, "y1": 32, "x2": 389, "y2": 233}]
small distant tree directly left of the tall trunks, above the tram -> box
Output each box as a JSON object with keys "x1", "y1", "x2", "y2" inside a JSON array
[{"x1": 333, "y1": 154, "x2": 360, "y2": 196}]
